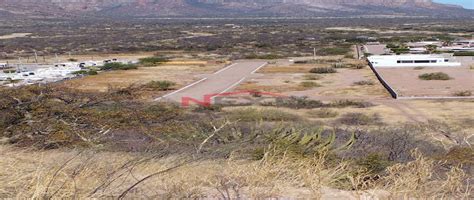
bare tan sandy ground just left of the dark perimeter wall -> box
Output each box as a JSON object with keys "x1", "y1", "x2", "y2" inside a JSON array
[{"x1": 238, "y1": 64, "x2": 389, "y2": 100}]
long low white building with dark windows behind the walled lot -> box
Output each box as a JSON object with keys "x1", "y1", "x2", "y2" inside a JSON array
[{"x1": 368, "y1": 54, "x2": 461, "y2": 67}]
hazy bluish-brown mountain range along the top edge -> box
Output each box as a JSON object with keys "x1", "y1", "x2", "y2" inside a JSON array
[{"x1": 0, "y1": 0, "x2": 474, "y2": 18}]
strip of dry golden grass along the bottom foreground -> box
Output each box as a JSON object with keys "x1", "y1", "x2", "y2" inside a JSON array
[{"x1": 0, "y1": 146, "x2": 472, "y2": 199}]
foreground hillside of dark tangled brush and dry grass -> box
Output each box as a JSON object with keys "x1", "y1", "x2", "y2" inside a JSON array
[{"x1": 0, "y1": 85, "x2": 473, "y2": 198}]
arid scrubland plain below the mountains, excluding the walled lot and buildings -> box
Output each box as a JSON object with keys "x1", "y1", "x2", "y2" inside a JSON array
[{"x1": 0, "y1": 18, "x2": 474, "y2": 199}]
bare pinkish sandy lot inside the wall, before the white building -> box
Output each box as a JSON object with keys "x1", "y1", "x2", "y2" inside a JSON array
[{"x1": 377, "y1": 67, "x2": 474, "y2": 97}]
